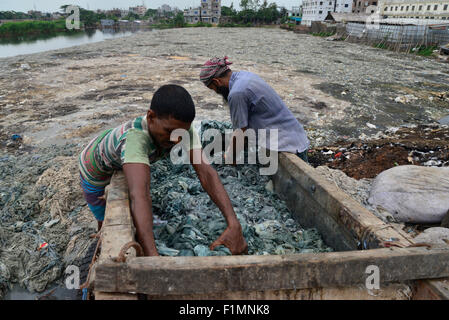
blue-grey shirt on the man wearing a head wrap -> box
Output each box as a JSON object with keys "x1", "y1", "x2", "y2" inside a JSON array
[{"x1": 228, "y1": 71, "x2": 310, "y2": 153}]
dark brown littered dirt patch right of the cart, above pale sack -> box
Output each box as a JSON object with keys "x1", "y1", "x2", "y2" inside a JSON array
[{"x1": 309, "y1": 125, "x2": 449, "y2": 180}]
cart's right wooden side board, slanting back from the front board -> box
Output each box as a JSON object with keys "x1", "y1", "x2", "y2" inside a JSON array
[{"x1": 273, "y1": 153, "x2": 449, "y2": 300}]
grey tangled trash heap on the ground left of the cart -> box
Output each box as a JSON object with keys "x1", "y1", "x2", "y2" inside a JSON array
[{"x1": 0, "y1": 145, "x2": 95, "y2": 299}]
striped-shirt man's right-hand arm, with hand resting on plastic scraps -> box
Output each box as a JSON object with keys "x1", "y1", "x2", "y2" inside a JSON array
[{"x1": 190, "y1": 149, "x2": 248, "y2": 254}]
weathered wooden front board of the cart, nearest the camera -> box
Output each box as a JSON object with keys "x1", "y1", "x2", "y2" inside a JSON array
[{"x1": 95, "y1": 246, "x2": 449, "y2": 296}]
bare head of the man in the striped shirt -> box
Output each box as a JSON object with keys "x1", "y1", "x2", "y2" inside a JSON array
[{"x1": 147, "y1": 84, "x2": 195, "y2": 149}]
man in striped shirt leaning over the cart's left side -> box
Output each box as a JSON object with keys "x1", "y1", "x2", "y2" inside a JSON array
[{"x1": 79, "y1": 85, "x2": 248, "y2": 256}]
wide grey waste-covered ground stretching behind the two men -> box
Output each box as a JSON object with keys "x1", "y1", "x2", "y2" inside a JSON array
[{"x1": 0, "y1": 28, "x2": 449, "y2": 146}]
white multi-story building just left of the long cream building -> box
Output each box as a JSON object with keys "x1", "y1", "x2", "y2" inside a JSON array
[{"x1": 301, "y1": 0, "x2": 353, "y2": 26}]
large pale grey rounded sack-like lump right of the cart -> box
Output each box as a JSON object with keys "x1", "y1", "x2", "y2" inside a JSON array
[{"x1": 368, "y1": 166, "x2": 449, "y2": 223}]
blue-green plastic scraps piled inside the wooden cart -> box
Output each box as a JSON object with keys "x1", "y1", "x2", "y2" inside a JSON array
[{"x1": 151, "y1": 121, "x2": 332, "y2": 256}]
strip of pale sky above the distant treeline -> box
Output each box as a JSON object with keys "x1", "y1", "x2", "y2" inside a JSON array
[{"x1": 0, "y1": 0, "x2": 301, "y2": 12}]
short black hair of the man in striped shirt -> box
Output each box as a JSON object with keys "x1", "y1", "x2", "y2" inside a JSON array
[{"x1": 150, "y1": 84, "x2": 195, "y2": 122}]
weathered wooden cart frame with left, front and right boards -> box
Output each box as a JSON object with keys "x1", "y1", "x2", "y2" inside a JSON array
[{"x1": 95, "y1": 154, "x2": 449, "y2": 299}]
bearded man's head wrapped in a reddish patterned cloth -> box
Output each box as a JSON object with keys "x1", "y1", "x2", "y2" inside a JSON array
[{"x1": 200, "y1": 57, "x2": 232, "y2": 101}]
